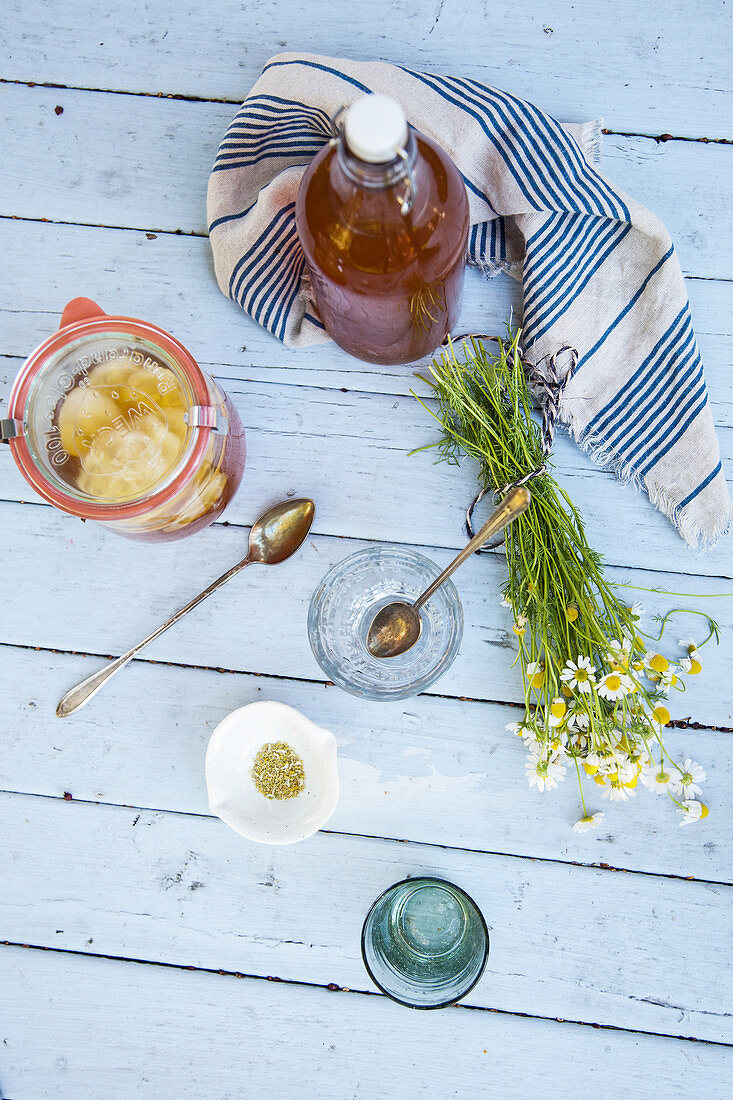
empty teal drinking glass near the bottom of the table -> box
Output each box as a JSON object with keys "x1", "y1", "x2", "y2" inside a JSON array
[{"x1": 361, "y1": 878, "x2": 489, "y2": 1009}]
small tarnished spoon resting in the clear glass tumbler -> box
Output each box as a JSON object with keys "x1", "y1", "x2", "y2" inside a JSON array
[{"x1": 367, "y1": 485, "x2": 532, "y2": 658}]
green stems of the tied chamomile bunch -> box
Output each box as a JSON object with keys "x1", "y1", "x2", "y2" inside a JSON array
[{"x1": 413, "y1": 330, "x2": 719, "y2": 816}]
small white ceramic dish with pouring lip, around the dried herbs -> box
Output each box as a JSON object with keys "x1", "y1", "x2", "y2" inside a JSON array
[{"x1": 206, "y1": 701, "x2": 339, "y2": 844}]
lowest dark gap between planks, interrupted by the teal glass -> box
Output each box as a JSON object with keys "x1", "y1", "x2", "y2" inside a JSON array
[{"x1": 0, "y1": 939, "x2": 733, "y2": 1048}]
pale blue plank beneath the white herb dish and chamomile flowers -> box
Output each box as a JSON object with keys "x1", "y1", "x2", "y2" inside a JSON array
[{"x1": 0, "y1": 647, "x2": 733, "y2": 881}]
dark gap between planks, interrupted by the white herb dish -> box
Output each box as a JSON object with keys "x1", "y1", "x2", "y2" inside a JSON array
[{"x1": 0, "y1": 789, "x2": 733, "y2": 888}]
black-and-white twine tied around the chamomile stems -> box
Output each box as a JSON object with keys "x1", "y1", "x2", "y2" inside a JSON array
[{"x1": 441, "y1": 332, "x2": 579, "y2": 553}]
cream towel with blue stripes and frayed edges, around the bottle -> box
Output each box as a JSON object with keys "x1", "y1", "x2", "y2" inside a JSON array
[{"x1": 208, "y1": 54, "x2": 733, "y2": 546}]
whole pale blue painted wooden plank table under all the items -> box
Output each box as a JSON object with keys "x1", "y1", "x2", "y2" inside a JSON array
[{"x1": 0, "y1": 0, "x2": 733, "y2": 1100}]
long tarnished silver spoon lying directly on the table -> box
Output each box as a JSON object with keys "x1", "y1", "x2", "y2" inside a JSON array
[{"x1": 56, "y1": 497, "x2": 316, "y2": 718}]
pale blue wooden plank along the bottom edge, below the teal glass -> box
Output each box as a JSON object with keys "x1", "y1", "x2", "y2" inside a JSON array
[{"x1": 2, "y1": 947, "x2": 731, "y2": 1100}]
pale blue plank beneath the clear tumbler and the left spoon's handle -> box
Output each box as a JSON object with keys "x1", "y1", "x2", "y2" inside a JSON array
[{"x1": 0, "y1": 501, "x2": 733, "y2": 726}]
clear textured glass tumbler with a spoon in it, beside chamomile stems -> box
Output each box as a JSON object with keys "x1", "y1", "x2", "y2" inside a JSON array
[{"x1": 308, "y1": 547, "x2": 463, "y2": 700}]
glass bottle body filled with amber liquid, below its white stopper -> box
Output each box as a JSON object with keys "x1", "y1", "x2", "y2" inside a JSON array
[{"x1": 296, "y1": 131, "x2": 469, "y2": 364}]
